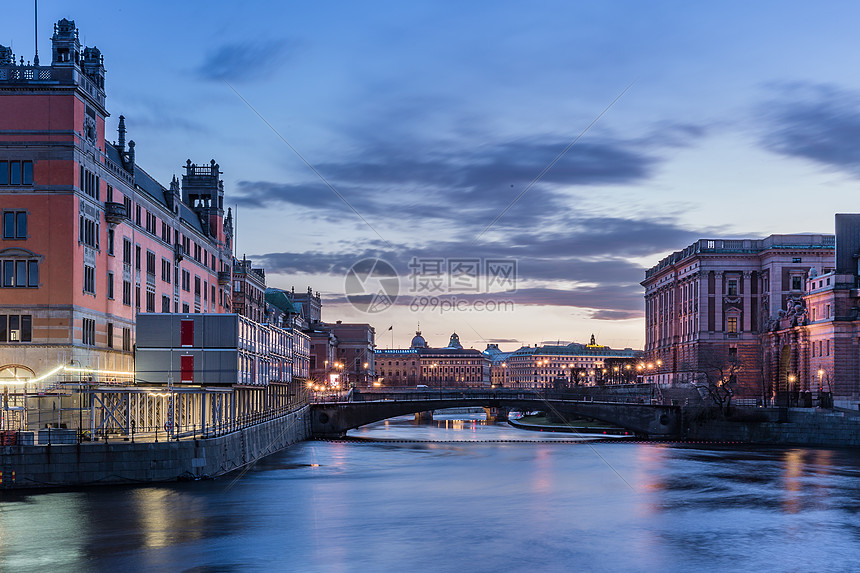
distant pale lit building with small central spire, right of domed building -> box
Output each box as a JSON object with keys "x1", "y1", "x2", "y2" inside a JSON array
[{"x1": 504, "y1": 335, "x2": 642, "y2": 388}]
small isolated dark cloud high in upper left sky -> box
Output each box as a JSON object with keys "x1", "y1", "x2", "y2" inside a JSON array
[{"x1": 195, "y1": 40, "x2": 296, "y2": 82}]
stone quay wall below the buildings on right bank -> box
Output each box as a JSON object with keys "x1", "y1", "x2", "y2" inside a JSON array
[{"x1": 686, "y1": 408, "x2": 860, "y2": 447}]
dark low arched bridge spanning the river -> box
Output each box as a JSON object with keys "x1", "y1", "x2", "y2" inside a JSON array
[{"x1": 311, "y1": 388, "x2": 683, "y2": 438}]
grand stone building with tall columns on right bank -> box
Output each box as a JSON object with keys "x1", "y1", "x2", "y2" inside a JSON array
[{"x1": 641, "y1": 235, "x2": 836, "y2": 398}]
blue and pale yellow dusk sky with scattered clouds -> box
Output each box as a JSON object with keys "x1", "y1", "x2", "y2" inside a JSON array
[{"x1": 6, "y1": 0, "x2": 860, "y2": 350}]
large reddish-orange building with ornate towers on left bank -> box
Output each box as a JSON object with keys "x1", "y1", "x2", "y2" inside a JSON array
[{"x1": 0, "y1": 19, "x2": 232, "y2": 379}]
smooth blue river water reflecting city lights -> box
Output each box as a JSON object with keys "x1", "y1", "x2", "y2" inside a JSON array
[{"x1": 0, "y1": 414, "x2": 860, "y2": 573}]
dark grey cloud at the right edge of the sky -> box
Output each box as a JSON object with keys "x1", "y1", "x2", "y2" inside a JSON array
[{"x1": 761, "y1": 83, "x2": 860, "y2": 176}]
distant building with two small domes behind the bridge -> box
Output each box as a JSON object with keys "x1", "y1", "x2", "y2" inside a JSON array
[{"x1": 376, "y1": 331, "x2": 490, "y2": 388}]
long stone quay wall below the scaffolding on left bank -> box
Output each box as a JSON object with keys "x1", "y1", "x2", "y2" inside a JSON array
[{"x1": 0, "y1": 406, "x2": 311, "y2": 489}]
